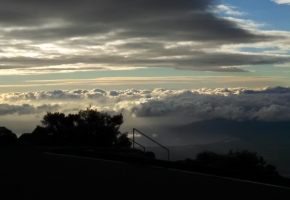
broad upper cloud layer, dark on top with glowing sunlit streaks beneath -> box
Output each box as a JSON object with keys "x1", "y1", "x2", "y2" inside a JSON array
[{"x1": 0, "y1": 0, "x2": 290, "y2": 75}]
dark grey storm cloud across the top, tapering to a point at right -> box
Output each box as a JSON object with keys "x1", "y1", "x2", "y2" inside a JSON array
[{"x1": 0, "y1": 0, "x2": 270, "y2": 43}]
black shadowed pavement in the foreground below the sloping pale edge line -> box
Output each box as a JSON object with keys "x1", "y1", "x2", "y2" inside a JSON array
[{"x1": 0, "y1": 147, "x2": 290, "y2": 200}]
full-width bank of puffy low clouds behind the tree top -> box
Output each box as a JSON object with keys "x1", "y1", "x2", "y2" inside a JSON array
[{"x1": 0, "y1": 87, "x2": 290, "y2": 123}]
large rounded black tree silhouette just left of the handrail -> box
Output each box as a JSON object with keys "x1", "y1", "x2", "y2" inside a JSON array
[{"x1": 22, "y1": 107, "x2": 131, "y2": 147}]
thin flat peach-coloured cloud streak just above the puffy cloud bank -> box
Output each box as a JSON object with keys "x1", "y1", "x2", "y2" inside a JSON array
[{"x1": 0, "y1": 76, "x2": 287, "y2": 88}]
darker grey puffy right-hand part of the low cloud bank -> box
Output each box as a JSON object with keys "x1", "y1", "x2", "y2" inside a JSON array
[{"x1": 115, "y1": 87, "x2": 290, "y2": 121}]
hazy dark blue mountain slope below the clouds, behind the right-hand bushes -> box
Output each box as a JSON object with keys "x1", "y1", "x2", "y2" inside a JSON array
[{"x1": 150, "y1": 118, "x2": 290, "y2": 177}]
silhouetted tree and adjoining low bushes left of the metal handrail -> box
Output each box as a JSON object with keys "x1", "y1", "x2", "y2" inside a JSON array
[{"x1": 0, "y1": 107, "x2": 159, "y2": 159}]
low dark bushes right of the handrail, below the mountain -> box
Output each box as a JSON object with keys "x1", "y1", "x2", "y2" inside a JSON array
[{"x1": 185, "y1": 150, "x2": 279, "y2": 175}]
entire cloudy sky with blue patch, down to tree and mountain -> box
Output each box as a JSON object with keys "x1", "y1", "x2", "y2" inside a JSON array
[{"x1": 0, "y1": 0, "x2": 290, "y2": 135}]
